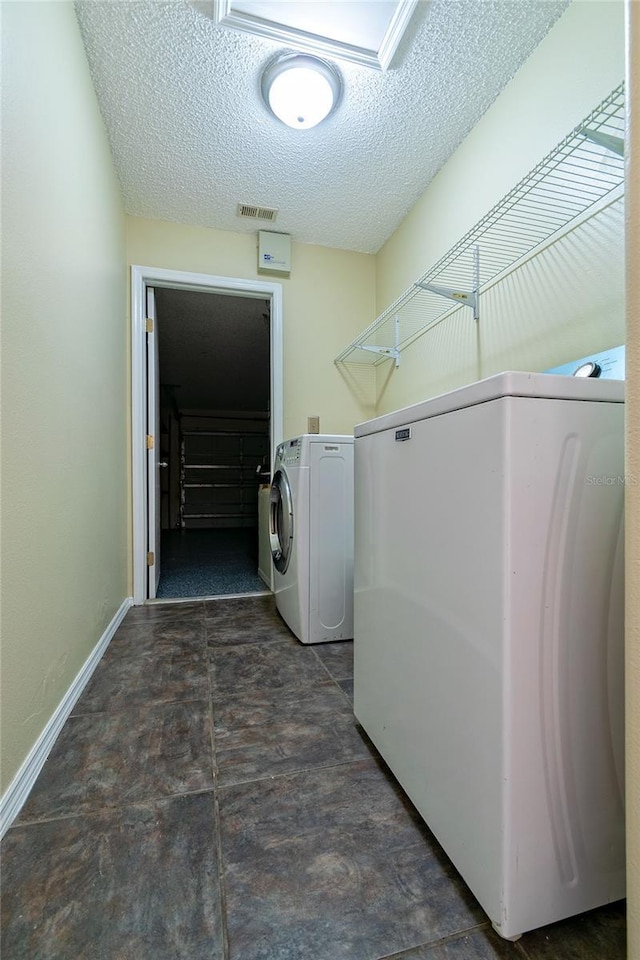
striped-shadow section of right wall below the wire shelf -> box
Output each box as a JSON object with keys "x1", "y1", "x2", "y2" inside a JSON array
[{"x1": 356, "y1": 199, "x2": 625, "y2": 415}]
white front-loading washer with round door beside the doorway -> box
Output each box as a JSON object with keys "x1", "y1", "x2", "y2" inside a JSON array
[{"x1": 269, "y1": 434, "x2": 353, "y2": 643}]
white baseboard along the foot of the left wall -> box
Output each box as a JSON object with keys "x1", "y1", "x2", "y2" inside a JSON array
[{"x1": 0, "y1": 597, "x2": 133, "y2": 838}]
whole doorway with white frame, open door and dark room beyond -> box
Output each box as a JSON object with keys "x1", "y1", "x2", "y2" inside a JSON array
[{"x1": 132, "y1": 267, "x2": 282, "y2": 603}]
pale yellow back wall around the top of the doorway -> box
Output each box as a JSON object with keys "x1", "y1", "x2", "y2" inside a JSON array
[{"x1": 127, "y1": 217, "x2": 375, "y2": 437}]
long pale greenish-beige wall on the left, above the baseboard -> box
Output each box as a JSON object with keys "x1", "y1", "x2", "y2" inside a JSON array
[{"x1": 2, "y1": 2, "x2": 127, "y2": 790}]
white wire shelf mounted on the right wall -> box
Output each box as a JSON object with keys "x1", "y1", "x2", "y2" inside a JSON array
[{"x1": 335, "y1": 84, "x2": 625, "y2": 365}]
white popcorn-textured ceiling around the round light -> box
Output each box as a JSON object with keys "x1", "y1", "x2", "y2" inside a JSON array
[{"x1": 76, "y1": 0, "x2": 569, "y2": 253}]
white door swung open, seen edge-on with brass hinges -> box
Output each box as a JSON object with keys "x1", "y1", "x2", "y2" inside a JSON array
[{"x1": 147, "y1": 287, "x2": 161, "y2": 600}]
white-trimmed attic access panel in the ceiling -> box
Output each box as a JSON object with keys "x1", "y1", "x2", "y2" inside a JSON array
[{"x1": 193, "y1": 0, "x2": 418, "y2": 70}]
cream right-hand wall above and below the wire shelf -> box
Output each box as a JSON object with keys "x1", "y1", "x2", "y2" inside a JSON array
[{"x1": 376, "y1": 0, "x2": 624, "y2": 413}]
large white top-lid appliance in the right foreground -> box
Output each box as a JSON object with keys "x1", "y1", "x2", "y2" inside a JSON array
[{"x1": 354, "y1": 373, "x2": 625, "y2": 939}]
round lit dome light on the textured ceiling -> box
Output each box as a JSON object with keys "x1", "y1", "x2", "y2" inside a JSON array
[{"x1": 262, "y1": 53, "x2": 340, "y2": 130}]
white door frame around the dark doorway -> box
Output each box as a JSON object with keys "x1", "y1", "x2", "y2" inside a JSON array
[{"x1": 131, "y1": 265, "x2": 283, "y2": 604}]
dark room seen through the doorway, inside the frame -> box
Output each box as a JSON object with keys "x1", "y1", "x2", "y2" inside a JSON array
[{"x1": 154, "y1": 287, "x2": 271, "y2": 599}]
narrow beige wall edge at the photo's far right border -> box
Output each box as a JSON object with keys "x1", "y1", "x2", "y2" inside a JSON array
[{"x1": 625, "y1": 0, "x2": 640, "y2": 960}]
